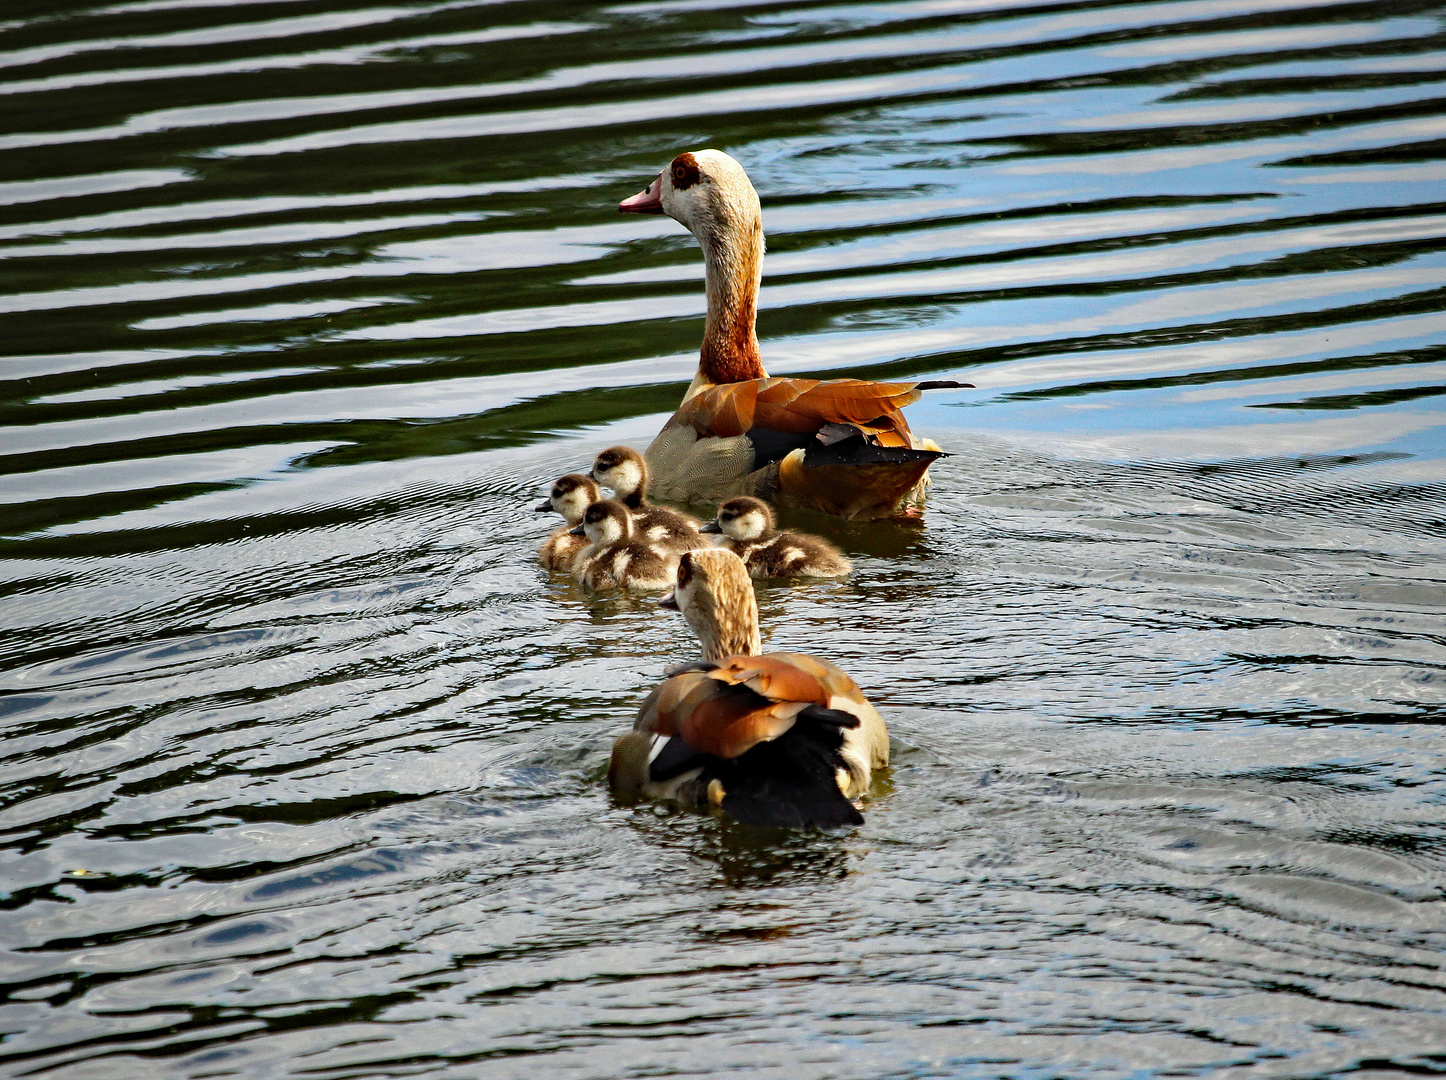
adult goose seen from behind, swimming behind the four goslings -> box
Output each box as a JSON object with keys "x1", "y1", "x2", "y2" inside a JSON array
[{"x1": 607, "y1": 548, "x2": 889, "y2": 828}]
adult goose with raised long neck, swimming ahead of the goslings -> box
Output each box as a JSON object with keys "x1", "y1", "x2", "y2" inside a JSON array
[{"x1": 617, "y1": 150, "x2": 969, "y2": 518}]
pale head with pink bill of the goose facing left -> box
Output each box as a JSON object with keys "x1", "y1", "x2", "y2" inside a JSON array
[{"x1": 617, "y1": 150, "x2": 763, "y2": 247}]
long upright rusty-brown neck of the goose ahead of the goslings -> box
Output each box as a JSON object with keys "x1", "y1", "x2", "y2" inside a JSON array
[{"x1": 688, "y1": 218, "x2": 768, "y2": 398}]
